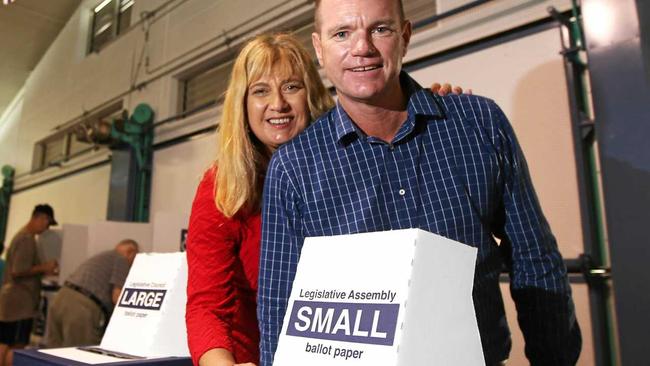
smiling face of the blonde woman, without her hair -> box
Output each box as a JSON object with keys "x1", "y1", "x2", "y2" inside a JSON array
[{"x1": 246, "y1": 72, "x2": 310, "y2": 151}]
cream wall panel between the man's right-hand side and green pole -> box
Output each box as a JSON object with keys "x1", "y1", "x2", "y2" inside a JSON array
[{"x1": 411, "y1": 29, "x2": 593, "y2": 365}]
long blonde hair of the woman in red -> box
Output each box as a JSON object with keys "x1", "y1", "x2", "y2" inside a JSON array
[{"x1": 215, "y1": 33, "x2": 334, "y2": 217}]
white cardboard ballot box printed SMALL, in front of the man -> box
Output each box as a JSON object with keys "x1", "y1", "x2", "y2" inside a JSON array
[{"x1": 274, "y1": 229, "x2": 485, "y2": 366}]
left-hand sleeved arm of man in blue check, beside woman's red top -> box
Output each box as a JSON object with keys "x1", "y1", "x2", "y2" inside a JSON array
[{"x1": 257, "y1": 154, "x2": 304, "y2": 366}]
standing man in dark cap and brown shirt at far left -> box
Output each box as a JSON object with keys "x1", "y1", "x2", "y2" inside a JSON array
[{"x1": 0, "y1": 204, "x2": 58, "y2": 365}]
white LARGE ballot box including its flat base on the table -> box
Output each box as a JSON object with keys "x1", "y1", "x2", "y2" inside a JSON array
[{"x1": 27, "y1": 253, "x2": 192, "y2": 366}]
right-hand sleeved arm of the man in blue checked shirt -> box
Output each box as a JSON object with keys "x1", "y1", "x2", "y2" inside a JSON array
[{"x1": 491, "y1": 104, "x2": 582, "y2": 365}]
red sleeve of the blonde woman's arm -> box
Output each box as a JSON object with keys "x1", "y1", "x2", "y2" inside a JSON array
[{"x1": 185, "y1": 169, "x2": 240, "y2": 365}]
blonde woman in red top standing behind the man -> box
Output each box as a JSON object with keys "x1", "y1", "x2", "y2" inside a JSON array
[{"x1": 186, "y1": 34, "x2": 334, "y2": 365}]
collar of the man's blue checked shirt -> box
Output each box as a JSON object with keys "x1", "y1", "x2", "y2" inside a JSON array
[{"x1": 330, "y1": 71, "x2": 443, "y2": 142}]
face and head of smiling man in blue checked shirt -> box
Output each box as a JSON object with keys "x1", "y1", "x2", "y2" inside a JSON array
[{"x1": 312, "y1": 0, "x2": 411, "y2": 104}]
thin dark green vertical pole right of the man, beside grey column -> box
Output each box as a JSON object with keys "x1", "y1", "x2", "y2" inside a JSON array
[{"x1": 549, "y1": 0, "x2": 616, "y2": 366}]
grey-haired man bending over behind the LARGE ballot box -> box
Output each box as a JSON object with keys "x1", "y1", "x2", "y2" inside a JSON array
[{"x1": 46, "y1": 239, "x2": 139, "y2": 347}]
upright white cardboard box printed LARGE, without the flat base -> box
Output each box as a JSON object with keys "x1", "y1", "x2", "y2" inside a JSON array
[{"x1": 100, "y1": 253, "x2": 190, "y2": 358}]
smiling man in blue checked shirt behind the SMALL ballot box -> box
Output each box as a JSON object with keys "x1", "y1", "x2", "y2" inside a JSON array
[{"x1": 258, "y1": 0, "x2": 581, "y2": 366}]
